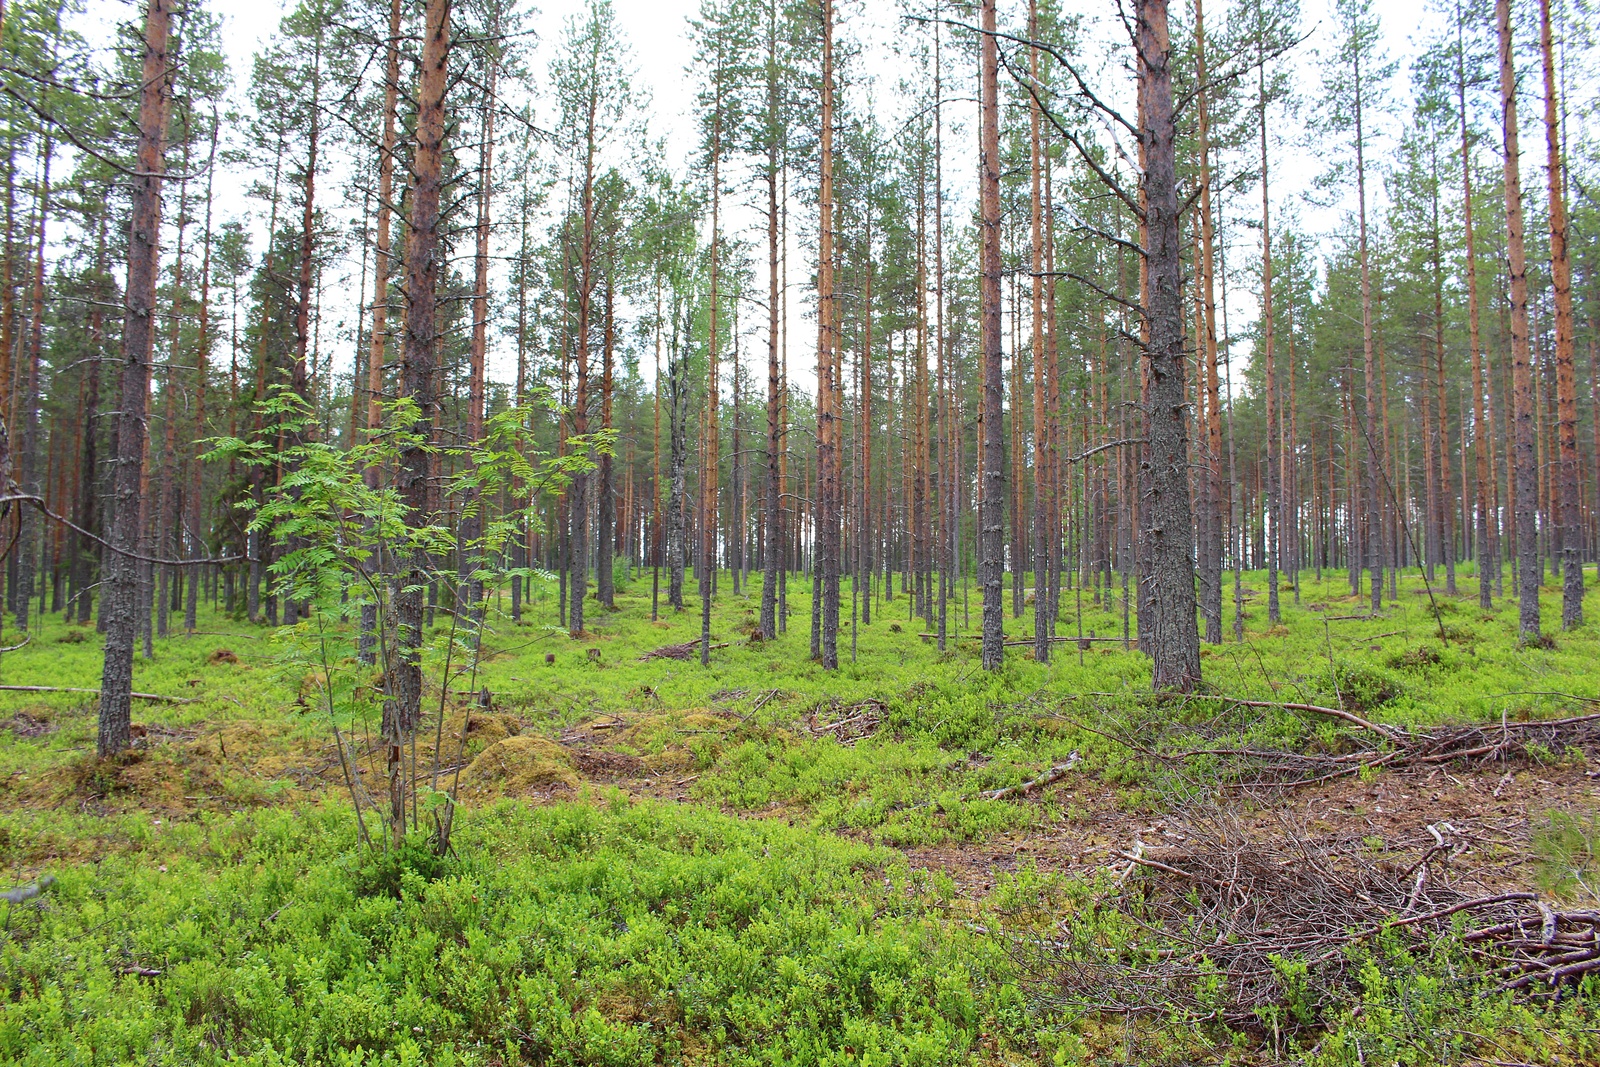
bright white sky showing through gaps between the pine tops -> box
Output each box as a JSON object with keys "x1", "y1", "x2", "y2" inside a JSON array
[{"x1": 90, "y1": 0, "x2": 1536, "y2": 404}]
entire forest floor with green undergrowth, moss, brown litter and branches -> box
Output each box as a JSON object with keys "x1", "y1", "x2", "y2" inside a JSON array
[{"x1": 0, "y1": 566, "x2": 1600, "y2": 1065}]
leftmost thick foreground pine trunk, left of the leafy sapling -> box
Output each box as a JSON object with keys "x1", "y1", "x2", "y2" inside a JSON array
[{"x1": 96, "y1": 0, "x2": 171, "y2": 758}]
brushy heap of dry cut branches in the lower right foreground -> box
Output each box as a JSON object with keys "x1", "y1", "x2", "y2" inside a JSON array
[{"x1": 1008, "y1": 803, "x2": 1600, "y2": 1035}]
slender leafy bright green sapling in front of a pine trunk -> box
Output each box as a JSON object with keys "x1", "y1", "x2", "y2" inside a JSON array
[{"x1": 206, "y1": 387, "x2": 601, "y2": 854}]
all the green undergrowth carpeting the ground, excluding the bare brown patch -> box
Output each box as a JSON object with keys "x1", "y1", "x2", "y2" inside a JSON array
[{"x1": 0, "y1": 566, "x2": 1600, "y2": 1065}]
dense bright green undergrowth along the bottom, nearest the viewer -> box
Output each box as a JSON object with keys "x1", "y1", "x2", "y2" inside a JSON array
[{"x1": 0, "y1": 793, "x2": 1600, "y2": 1067}]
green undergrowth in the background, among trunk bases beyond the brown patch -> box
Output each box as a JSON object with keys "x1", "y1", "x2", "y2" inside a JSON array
[{"x1": 0, "y1": 566, "x2": 1600, "y2": 846}]
